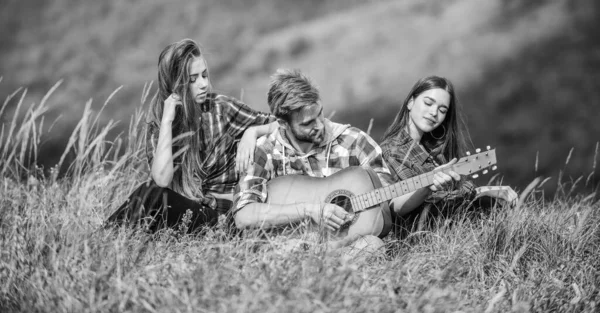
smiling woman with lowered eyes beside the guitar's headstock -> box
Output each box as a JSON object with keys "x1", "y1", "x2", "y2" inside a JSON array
[{"x1": 381, "y1": 76, "x2": 517, "y2": 230}]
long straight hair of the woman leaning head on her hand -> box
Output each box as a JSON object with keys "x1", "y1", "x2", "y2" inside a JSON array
[{"x1": 149, "y1": 39, "x2": 210, "y2": 200}]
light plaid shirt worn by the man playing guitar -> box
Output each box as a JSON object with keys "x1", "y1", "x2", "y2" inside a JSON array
[{"x1": 233, "y1": 119, "x2": 393, "y2": 213}]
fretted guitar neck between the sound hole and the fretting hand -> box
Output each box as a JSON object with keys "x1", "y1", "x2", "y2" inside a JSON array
[{"x1": 350, "y1": 170, "x2": 437, "y2": 212}]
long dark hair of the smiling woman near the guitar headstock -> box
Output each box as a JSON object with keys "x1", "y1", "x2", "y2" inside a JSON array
[{"x1": 382, "y1": 76, "x2": 467, "y2": 161}]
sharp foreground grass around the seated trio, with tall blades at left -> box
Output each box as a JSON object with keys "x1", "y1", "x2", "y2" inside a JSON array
[{"x1": 0, "y1": 84, "x2": 600, "y2": 312}]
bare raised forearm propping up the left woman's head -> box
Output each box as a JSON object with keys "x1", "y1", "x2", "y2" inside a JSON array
[{"x1": 151, "y1": 94, "x2": 181, "y2": 187}]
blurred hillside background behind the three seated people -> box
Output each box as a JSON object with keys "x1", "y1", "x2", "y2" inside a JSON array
[{"x1": 0, "y1": 0, "x2": 600, "y2": 192}]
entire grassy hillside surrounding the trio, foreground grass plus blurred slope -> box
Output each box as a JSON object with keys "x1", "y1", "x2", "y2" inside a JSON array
[{"x1": 0, "y1": 0, "x2": 600, "y2": 312}]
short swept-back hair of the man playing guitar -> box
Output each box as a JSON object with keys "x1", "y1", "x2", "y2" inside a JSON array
[{"x1": 267, "y1": 69, "x2": 321, "y2": 121}]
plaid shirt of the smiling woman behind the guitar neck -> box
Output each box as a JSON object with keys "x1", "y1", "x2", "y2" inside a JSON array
[{"x1": 381, "y1": 130, "x2": 475, "y2": 204}]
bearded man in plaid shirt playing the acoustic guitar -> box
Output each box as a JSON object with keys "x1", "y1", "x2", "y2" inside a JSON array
[{"x1": 233, "y1": 70, "x2": 454, "y2": 248}]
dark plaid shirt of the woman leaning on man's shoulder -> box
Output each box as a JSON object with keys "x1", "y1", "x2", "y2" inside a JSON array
[{"x1": 146, "y1": 94, "x2": 276, "y2": 208}]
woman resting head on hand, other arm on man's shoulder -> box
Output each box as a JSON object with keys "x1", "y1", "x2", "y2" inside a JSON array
[{"x1": 107, "y1": 39, "x2": 278, "y2": 232}]
